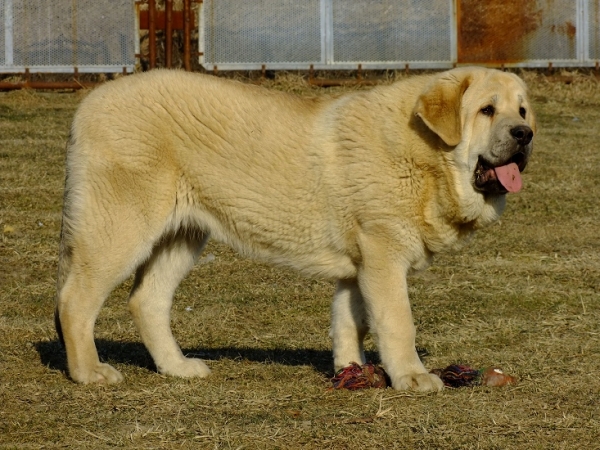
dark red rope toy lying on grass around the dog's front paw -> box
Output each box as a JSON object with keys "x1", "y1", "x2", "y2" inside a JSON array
[{"x1": 331, "y1": 362, "x2": 517, "y2": 391}]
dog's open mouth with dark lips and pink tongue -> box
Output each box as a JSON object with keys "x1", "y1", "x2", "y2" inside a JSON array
[{"x1": 474, "y1": 152, "x2": 527, "y2": 194}]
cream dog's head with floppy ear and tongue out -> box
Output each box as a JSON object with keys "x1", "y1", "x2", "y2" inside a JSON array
[{"x1": 415, "y1": 68, "x2": 536, "y2": 195}]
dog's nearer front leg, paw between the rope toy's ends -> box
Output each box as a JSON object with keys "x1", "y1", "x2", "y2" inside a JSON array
[{"x1": 358, "y1": 236, "x2": 444, "y2": 392}]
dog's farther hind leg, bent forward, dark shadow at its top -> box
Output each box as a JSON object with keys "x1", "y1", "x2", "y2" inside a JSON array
[{"x1": 129, "y1": 232, "x2": 210, "y2": 377}]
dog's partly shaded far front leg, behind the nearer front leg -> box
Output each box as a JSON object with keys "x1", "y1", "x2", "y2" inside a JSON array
[{"x1": 330, "y1": 280, "x2": 369, "y2": 371}]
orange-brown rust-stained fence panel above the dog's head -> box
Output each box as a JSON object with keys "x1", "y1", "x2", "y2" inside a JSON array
[{"x1": 457, "y1": 0, "x2": 576, "y2": 64}]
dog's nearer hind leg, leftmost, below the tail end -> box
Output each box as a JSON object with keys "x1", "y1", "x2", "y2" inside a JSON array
[{"x1": 55, "y1": 218, "x2": 152, "y2": 383}]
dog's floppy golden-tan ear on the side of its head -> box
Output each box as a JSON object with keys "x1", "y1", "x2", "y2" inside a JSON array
[{"x1": 415, "y1": 70, "x2": 471, "y2": 147}]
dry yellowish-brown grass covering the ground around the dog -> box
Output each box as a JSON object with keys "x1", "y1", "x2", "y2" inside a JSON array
[{"x1": 0, "y1": 72, "x2": 600, "y2": 449}]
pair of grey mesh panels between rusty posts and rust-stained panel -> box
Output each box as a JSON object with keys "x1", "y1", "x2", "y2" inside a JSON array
[{"x1": 199, "y1": 0, "x2": 452, "y2": 70}]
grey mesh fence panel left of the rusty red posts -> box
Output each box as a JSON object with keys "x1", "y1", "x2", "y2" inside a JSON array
[{"x1": 0, "y1": 0, "x2": 136, "y2": 72}]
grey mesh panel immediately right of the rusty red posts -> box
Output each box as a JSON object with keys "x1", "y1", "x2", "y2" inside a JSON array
[{"x1": 201, "y1": 0, "x2": 321, "y2": 67}]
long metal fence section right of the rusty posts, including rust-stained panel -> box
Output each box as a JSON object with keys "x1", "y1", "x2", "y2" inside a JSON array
[{"x1": 199, "y1": 0, "x2": 600, "y2": 70}]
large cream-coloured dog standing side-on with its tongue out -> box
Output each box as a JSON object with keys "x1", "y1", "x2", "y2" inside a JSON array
[{"x1": 56, "y1": 68, "x2": 535, "y2": 391}]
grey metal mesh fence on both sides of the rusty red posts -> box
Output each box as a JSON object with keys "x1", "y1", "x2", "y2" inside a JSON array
[{"x1": 0, "y1": 0, "x2": 600, "y2": 73}]
